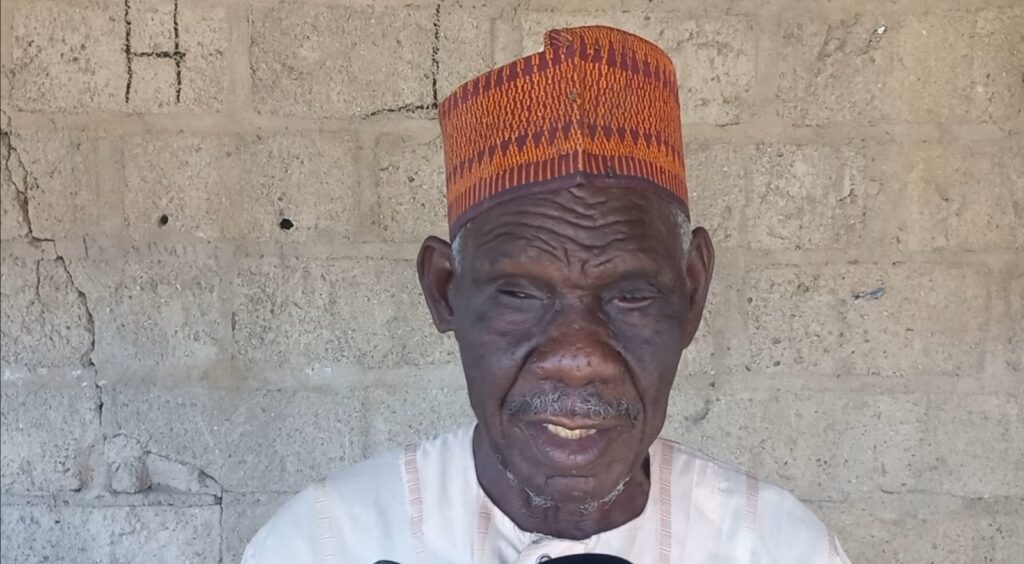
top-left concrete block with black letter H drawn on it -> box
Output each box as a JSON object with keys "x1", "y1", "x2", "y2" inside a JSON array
[{"x1": 9, "y1": 0, "x2": 230, "y2": 113}]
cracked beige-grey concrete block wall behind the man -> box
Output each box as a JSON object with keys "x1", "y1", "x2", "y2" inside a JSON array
[{"x1": 0, "y1": 0, "x2": 1024, "y2": 564}]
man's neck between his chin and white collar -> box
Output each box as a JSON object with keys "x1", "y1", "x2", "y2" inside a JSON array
[{"x1": 473, "y1": 427, "x2": 650, "y2": 539}]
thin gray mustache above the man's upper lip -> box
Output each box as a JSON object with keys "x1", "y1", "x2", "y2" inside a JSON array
[{"x1": 505, "y1": 387, "x2": 640, "y2": 423}]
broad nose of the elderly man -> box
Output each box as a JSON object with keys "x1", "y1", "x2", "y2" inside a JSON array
[{"x1": 530, "y1": 307, "x2": 626, "y2": 387}]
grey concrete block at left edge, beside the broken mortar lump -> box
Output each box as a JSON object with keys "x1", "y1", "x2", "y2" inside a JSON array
[{"x1": 0, "y1": 386, "x2": 99, "y2": 495}]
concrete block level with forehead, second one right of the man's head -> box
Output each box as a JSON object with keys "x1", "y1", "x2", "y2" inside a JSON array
[{"x1": 749, "y1": 143, "x2": 880, "y2": 250}]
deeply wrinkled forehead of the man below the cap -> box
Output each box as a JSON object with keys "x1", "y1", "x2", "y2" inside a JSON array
[{"x1": 463, "y1": 185, "x2": 681, "y2": 278}]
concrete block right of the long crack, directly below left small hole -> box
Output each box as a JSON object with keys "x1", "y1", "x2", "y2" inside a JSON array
[{"x1": 71, "y1": 256, "x2": 228, "y2": 370}]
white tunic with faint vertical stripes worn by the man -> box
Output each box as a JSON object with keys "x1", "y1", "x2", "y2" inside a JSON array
[{"x1": 242, "y1": 427, "x2": 849, "y2": 564}]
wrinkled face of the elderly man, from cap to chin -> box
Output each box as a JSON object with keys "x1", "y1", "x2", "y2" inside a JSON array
[{"x1": 421, "y1": 187, "x2": 710, "y2": 505}]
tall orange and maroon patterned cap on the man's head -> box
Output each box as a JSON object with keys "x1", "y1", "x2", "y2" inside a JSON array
[{"x1": 438, "y1": 26, "x2": 689, "y2": 236}]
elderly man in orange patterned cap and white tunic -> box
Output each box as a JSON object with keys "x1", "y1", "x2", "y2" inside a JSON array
[{"x1": 245, "y1": 27, "x2": 847, "y2": 564}]
